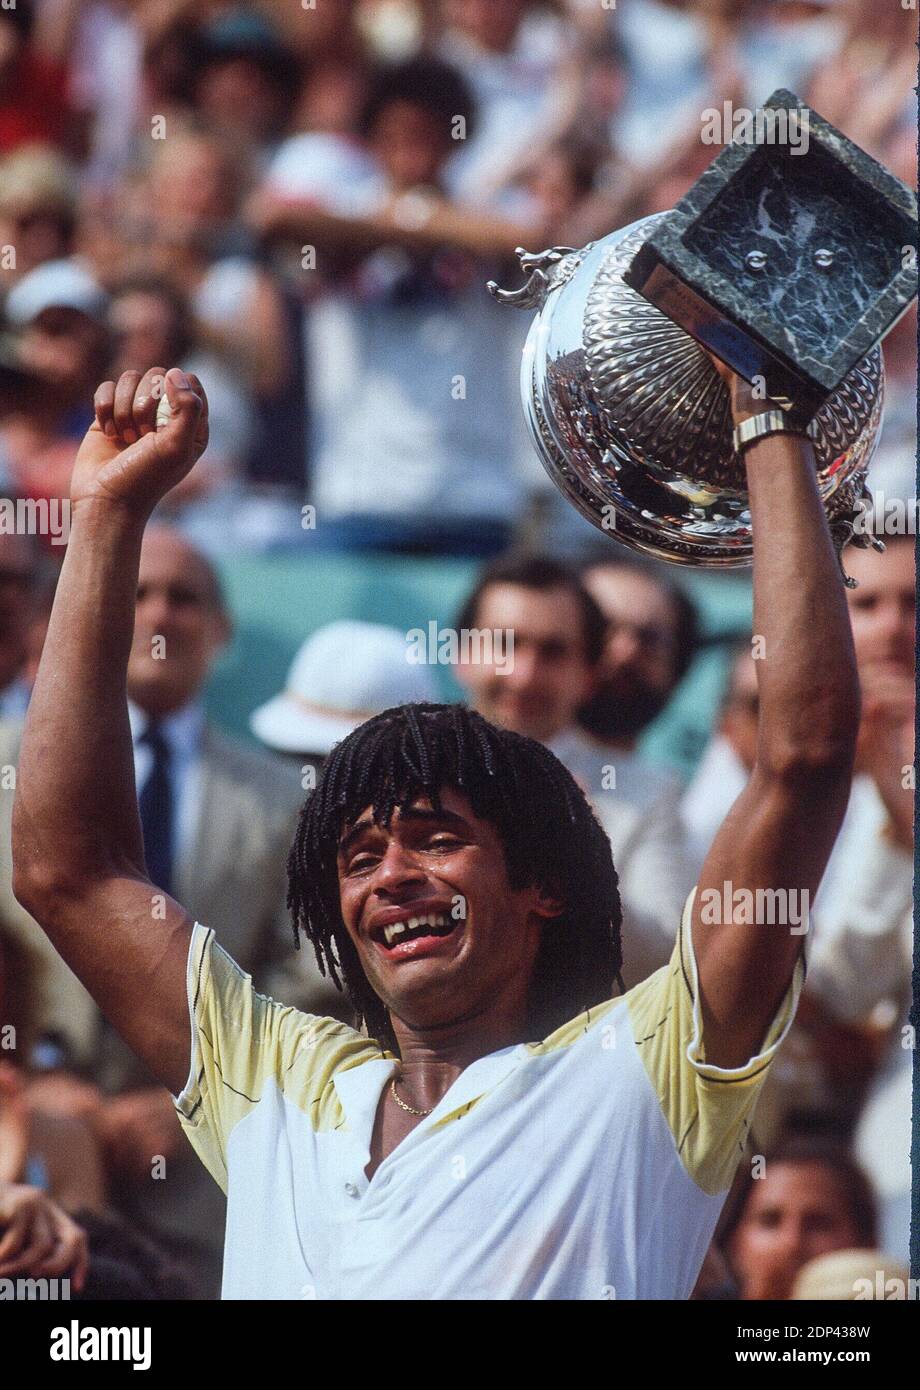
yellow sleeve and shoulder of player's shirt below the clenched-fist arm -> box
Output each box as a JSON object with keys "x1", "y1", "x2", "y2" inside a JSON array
[{"x1": 174, "y1": 923, "x2": 381, "y2": 1191}]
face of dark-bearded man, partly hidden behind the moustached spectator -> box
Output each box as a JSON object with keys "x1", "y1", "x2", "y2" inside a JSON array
[{"x1": 582, "y1": 566, "x2": 675, "y2": 739}]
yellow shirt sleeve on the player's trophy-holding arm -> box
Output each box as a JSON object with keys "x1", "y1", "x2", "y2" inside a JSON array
[{"x1": 627, "y1": 890, "x2": 805, "y2": 1195}]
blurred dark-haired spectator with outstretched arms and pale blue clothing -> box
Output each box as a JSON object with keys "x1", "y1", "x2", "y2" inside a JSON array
[{"x1": 250, "y1": 58, "x2": 532, "y2": 555}]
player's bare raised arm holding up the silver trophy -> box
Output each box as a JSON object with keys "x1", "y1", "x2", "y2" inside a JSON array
[{"x1": 692, "y1": 368, "x2": 859, "y2": 1068}]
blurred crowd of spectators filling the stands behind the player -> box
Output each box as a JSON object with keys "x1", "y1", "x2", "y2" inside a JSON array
[{"x1": 0, "y1": 0, "x2": 916, "y2": 1298}]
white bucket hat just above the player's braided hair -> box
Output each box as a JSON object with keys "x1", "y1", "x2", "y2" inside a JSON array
[{"x1": 249, "y1": 621, "x2": 438, "y2": 756}]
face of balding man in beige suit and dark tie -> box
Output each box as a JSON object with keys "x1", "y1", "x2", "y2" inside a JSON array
[{"x1": 128, "y1": 530, "x2": 228, "y2": 716}]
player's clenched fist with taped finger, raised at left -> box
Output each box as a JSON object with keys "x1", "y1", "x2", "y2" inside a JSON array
[{"x1": 71, "y1": 367, "x2": 207, "y2": 518}]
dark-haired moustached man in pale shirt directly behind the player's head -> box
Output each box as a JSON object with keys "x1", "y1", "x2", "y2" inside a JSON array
[{"x1": 456, "y1": 557, "x2": 691, "y2": 988}]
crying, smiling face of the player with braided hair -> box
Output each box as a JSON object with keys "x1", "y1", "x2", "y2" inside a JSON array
[{"x1": 338, "y1": 788, "x2": 560, "y2": 1029}]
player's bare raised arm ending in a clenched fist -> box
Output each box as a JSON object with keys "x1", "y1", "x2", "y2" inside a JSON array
[{"x1": 13, "y1": 368, "x2": 207, "y2": 1093}]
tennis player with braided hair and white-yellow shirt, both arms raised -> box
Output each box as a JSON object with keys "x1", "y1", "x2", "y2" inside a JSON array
[{"x1": 14, "y1": 370, "x2": 859, "y2": 1300}]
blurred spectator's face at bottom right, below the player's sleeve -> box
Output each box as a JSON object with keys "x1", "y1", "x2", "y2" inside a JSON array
[{"x1": 730, "y1": 1162, "x2": 860, "y2": 1300}]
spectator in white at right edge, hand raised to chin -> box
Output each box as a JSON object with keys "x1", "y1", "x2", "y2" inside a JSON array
[{"x1": 809, "y1": 535, "x2": 916, "y2": 1259}]
